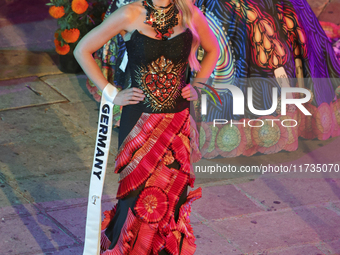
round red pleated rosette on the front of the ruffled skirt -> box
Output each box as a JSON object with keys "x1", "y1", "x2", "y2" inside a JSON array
[{"x1": 134, "y1": 187, "x2": 169, "y2": 223}]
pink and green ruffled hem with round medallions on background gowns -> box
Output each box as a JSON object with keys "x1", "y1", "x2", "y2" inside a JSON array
[{"x1": 198, "y1": 99, "x2": 340, "y2": 156}]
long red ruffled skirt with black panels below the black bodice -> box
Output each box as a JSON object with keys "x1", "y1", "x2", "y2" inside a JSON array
[{"x1": 101, "y1": 108, "x2": 202, "y2": 255}]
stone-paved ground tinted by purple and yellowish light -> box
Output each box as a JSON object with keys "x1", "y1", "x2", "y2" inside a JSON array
[{"x1": 0, "y1": 0, "x2": 340, "y2": 255}]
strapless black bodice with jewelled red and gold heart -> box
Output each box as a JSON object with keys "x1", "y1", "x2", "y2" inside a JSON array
[{"x1": 125, "y1": 28, "x2": 192, "y2": 113}]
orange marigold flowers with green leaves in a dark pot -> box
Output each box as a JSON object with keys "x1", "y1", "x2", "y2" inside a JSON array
[{"x1": 47, "y1": 0, "x2": 110, "y2": 55}]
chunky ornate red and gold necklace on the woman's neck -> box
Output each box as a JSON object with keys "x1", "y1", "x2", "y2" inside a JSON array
[{"x1": 143, "y1": 0, "x2": 179, "y2": 41}]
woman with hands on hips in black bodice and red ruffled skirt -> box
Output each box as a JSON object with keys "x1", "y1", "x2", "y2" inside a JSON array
[{"x1": 75, "y1": 0, "x2": 219, "y2": 255}]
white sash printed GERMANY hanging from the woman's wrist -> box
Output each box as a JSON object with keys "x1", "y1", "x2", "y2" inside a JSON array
[{"x1": 83, "y1": 83, "x2": 118, "y2": 255}]
